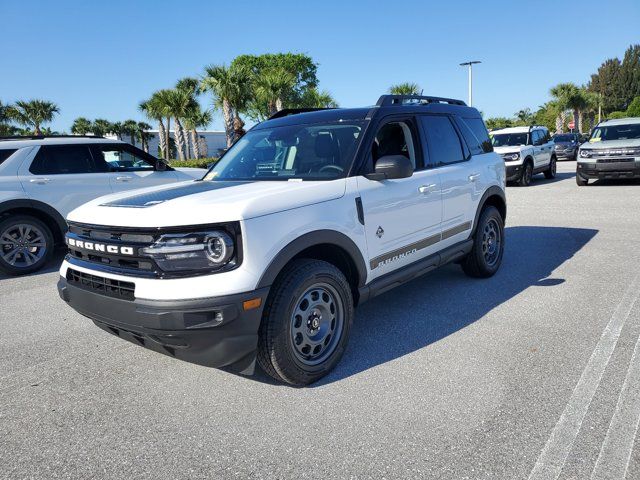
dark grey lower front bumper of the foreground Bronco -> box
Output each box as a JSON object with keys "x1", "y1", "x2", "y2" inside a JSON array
[{"x1": 58, "y1": 277, "x2": 269, "y2": 374}]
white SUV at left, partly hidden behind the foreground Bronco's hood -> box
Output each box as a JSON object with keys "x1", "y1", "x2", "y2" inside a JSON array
[{"x1": 0, "y1": 136, "x2": 206, "y2": 275}]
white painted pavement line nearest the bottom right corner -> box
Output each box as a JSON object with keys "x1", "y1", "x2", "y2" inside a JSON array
[{"x1": 591, "y1": 300, "x2": 640, "y2": 480}]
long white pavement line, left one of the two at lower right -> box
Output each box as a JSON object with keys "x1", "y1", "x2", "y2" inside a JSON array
[{"x1": 529, "y1": 274, "x2": 640, "y2": 480}]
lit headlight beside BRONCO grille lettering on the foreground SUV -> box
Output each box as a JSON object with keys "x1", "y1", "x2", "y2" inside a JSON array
[{"x1": 141, "y1": 230, "x2": 235, "y2": 272}]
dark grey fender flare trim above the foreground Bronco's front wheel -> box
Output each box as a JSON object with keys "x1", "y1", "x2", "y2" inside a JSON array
[{"x1": 256, "y1": 230, "x2": 367, "y2": 289}]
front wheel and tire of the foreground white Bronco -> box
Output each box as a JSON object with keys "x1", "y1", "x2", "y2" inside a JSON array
[{"x1": 258, "y1": 259, "x2": 354, "y2": 386}]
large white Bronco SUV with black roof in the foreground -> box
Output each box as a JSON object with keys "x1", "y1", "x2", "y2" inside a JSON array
[{"x1": 58, "y1": 95, "x2": 506, "y2": 385}]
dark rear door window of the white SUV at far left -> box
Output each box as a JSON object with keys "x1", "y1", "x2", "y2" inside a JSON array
[{"x1": 29, "y1": 145, "x2": 95, "y2": 175}]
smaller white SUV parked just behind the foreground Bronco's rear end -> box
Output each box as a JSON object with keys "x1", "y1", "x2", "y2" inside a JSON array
[{"x1": 491, "y1": 126, "x2": 558, "y2": 187}]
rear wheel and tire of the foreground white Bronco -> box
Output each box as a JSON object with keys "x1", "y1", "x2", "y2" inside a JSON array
[{"x1": 461, "y1": 206, "x2": 504, "y2": 278}]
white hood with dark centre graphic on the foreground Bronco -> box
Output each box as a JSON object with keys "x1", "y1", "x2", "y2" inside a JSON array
[{"x1": 67, "y1": 178, "x2": 346, "y2": 228}]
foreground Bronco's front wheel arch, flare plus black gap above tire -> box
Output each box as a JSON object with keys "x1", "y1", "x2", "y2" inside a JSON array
[{"x1": 256, "y1": 230, "x2": 367, "y2": 303}]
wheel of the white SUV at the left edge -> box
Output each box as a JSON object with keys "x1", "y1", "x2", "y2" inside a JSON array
[{"x1": 0, "y1": 215, "x2": 54, "y2": 275}]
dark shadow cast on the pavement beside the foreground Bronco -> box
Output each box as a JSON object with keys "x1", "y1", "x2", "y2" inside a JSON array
[{"x1": 311, "y1": 226, "x2": 598, "y2": 387}]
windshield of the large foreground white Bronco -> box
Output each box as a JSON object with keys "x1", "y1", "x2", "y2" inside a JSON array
[{"x1": 204, "y1": 122, "x2": 363, "y2": 180}]
